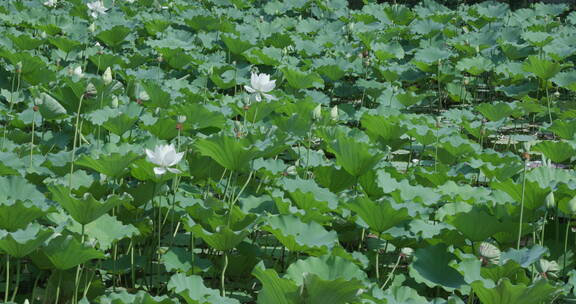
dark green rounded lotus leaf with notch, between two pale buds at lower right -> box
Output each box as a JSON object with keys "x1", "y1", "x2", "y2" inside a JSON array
[{"x1": 409, "y1": 244, "x2": 466, "y2": 291}]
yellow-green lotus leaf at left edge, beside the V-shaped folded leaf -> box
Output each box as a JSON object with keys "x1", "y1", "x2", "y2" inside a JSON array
[{"x1": 0, "y1": 200, "x2": 51, "y2": 231}]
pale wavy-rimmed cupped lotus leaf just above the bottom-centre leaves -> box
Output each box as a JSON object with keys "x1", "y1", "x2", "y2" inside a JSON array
[{"x1": 262, "y1": 215, "x2": 338, "y2": 255}]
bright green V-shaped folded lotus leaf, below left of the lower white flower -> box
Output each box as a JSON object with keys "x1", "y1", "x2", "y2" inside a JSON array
[{"x1": 48, "y1": 185, "x2": 132, "y2": 225}]
